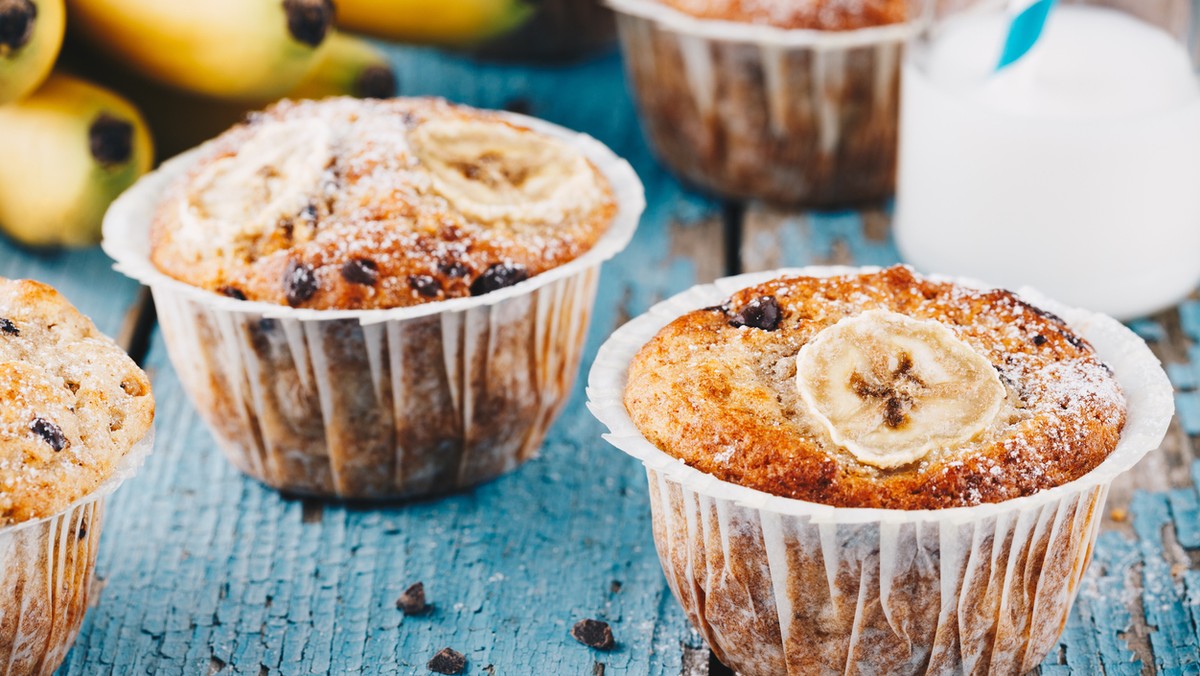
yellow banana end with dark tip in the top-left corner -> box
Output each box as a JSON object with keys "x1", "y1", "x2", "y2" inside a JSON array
[{"x1": 0, "y1": 0, "x2": 66, "y2": 104}]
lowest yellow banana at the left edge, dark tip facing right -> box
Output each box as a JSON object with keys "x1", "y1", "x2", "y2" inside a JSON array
[{"x1": 0, "y1": 73, "x2": 154, "y2": 246}]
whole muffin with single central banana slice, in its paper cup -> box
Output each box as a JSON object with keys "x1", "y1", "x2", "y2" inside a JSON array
[{"x1": 588, "y1": 268, "x2": 1174, "y2": 676}]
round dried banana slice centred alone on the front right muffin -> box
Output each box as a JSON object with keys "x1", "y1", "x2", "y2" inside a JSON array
[{"x1": 796, "y1": 310, "x2": 1007, "y2": 469}]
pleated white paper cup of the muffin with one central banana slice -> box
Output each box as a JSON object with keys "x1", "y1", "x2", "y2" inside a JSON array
[{"x1": 588, "y1": 268, "x2": 1174, "y2": 676}]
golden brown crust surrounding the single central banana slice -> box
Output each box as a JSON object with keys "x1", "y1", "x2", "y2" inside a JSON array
[{"x1": 625, "y1": 267, "x2": 1124, "y2": 509}]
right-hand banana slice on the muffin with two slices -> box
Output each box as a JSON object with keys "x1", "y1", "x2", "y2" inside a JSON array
[{"x1": 408, "y1": 120, "x2": 602, "y2": 223}]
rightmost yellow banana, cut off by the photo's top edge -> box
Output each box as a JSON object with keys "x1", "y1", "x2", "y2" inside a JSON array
[{"x1": 337, "y1": 0, "x2": 534, "y2": 44}]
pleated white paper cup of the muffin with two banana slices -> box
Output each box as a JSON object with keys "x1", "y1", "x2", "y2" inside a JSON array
[{"x1": 103, "y1": 114, "x2": 644, "y2": 499}]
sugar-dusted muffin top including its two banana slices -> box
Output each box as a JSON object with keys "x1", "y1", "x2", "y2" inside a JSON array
[{"x1": 151, "y1": 97, "x2": 617, "y2": 310}]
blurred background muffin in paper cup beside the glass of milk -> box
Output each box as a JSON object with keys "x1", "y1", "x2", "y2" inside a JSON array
[{"x1": 608, "y1": 0, "x2": 910, "y2": 207}]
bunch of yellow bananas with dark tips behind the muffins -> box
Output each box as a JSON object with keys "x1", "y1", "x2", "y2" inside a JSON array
[{"x1": 0, "y1": 0, "x2": 472, "y2": 246}]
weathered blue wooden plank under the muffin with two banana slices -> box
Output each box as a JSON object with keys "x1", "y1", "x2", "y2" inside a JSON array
[{"x1": 62, "y1": 49, "x2": 724, "y2": 675}]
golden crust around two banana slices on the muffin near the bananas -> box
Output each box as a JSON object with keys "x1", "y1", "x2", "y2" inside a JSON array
[{"x1": 151, "y1": 98, "x2": 617, "y2": 310}]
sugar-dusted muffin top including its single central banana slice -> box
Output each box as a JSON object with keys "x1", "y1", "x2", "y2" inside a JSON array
[{"x1": 625, "y1": 267, "x2": 1126, "y2": 509}]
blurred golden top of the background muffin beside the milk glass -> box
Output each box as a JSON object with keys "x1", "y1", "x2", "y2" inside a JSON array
[{"x1": 658, "y1": 0, "x2": 907, "y2": 30}]
